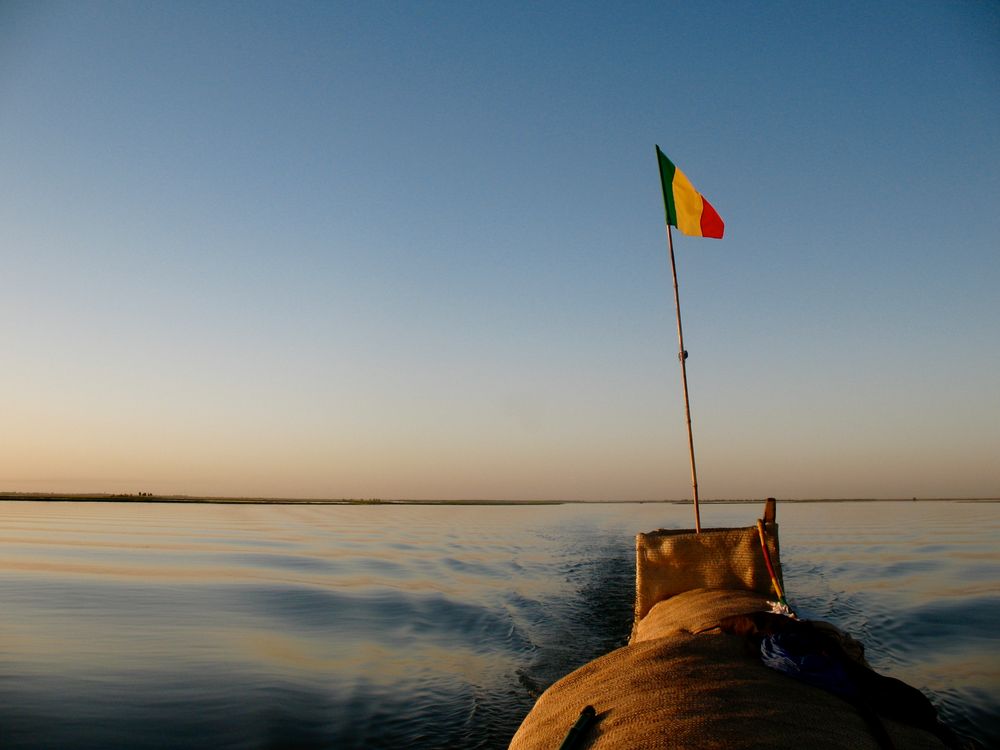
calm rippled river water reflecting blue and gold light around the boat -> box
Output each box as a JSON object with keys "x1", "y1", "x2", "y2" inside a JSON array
[{"x1": 0, "y1": 502, "x2": 1000, "y2": 750}]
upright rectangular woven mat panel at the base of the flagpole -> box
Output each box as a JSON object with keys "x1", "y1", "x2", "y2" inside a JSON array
[{"x1": 633, "y1": 523, "x2": 781, "y2": 633}]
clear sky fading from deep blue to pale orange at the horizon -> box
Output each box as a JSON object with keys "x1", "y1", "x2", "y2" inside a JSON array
[{"x1": 0, "y1": 0, "x2": 1000, "y2": 500}]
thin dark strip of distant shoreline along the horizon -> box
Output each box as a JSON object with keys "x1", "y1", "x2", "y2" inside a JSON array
[{"x1": 0, "y1": 492, "x2": 1000, "y2": 505}]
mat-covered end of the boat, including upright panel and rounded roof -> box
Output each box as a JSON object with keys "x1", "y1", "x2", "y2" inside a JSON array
[{"x1": 510, "y1": 500, "x2": 951, "y2": 750}]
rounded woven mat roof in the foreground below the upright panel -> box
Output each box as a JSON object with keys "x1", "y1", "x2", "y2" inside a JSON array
[{"x1": 510, "y1": 633, "x2": 945, "y2": 750}]
